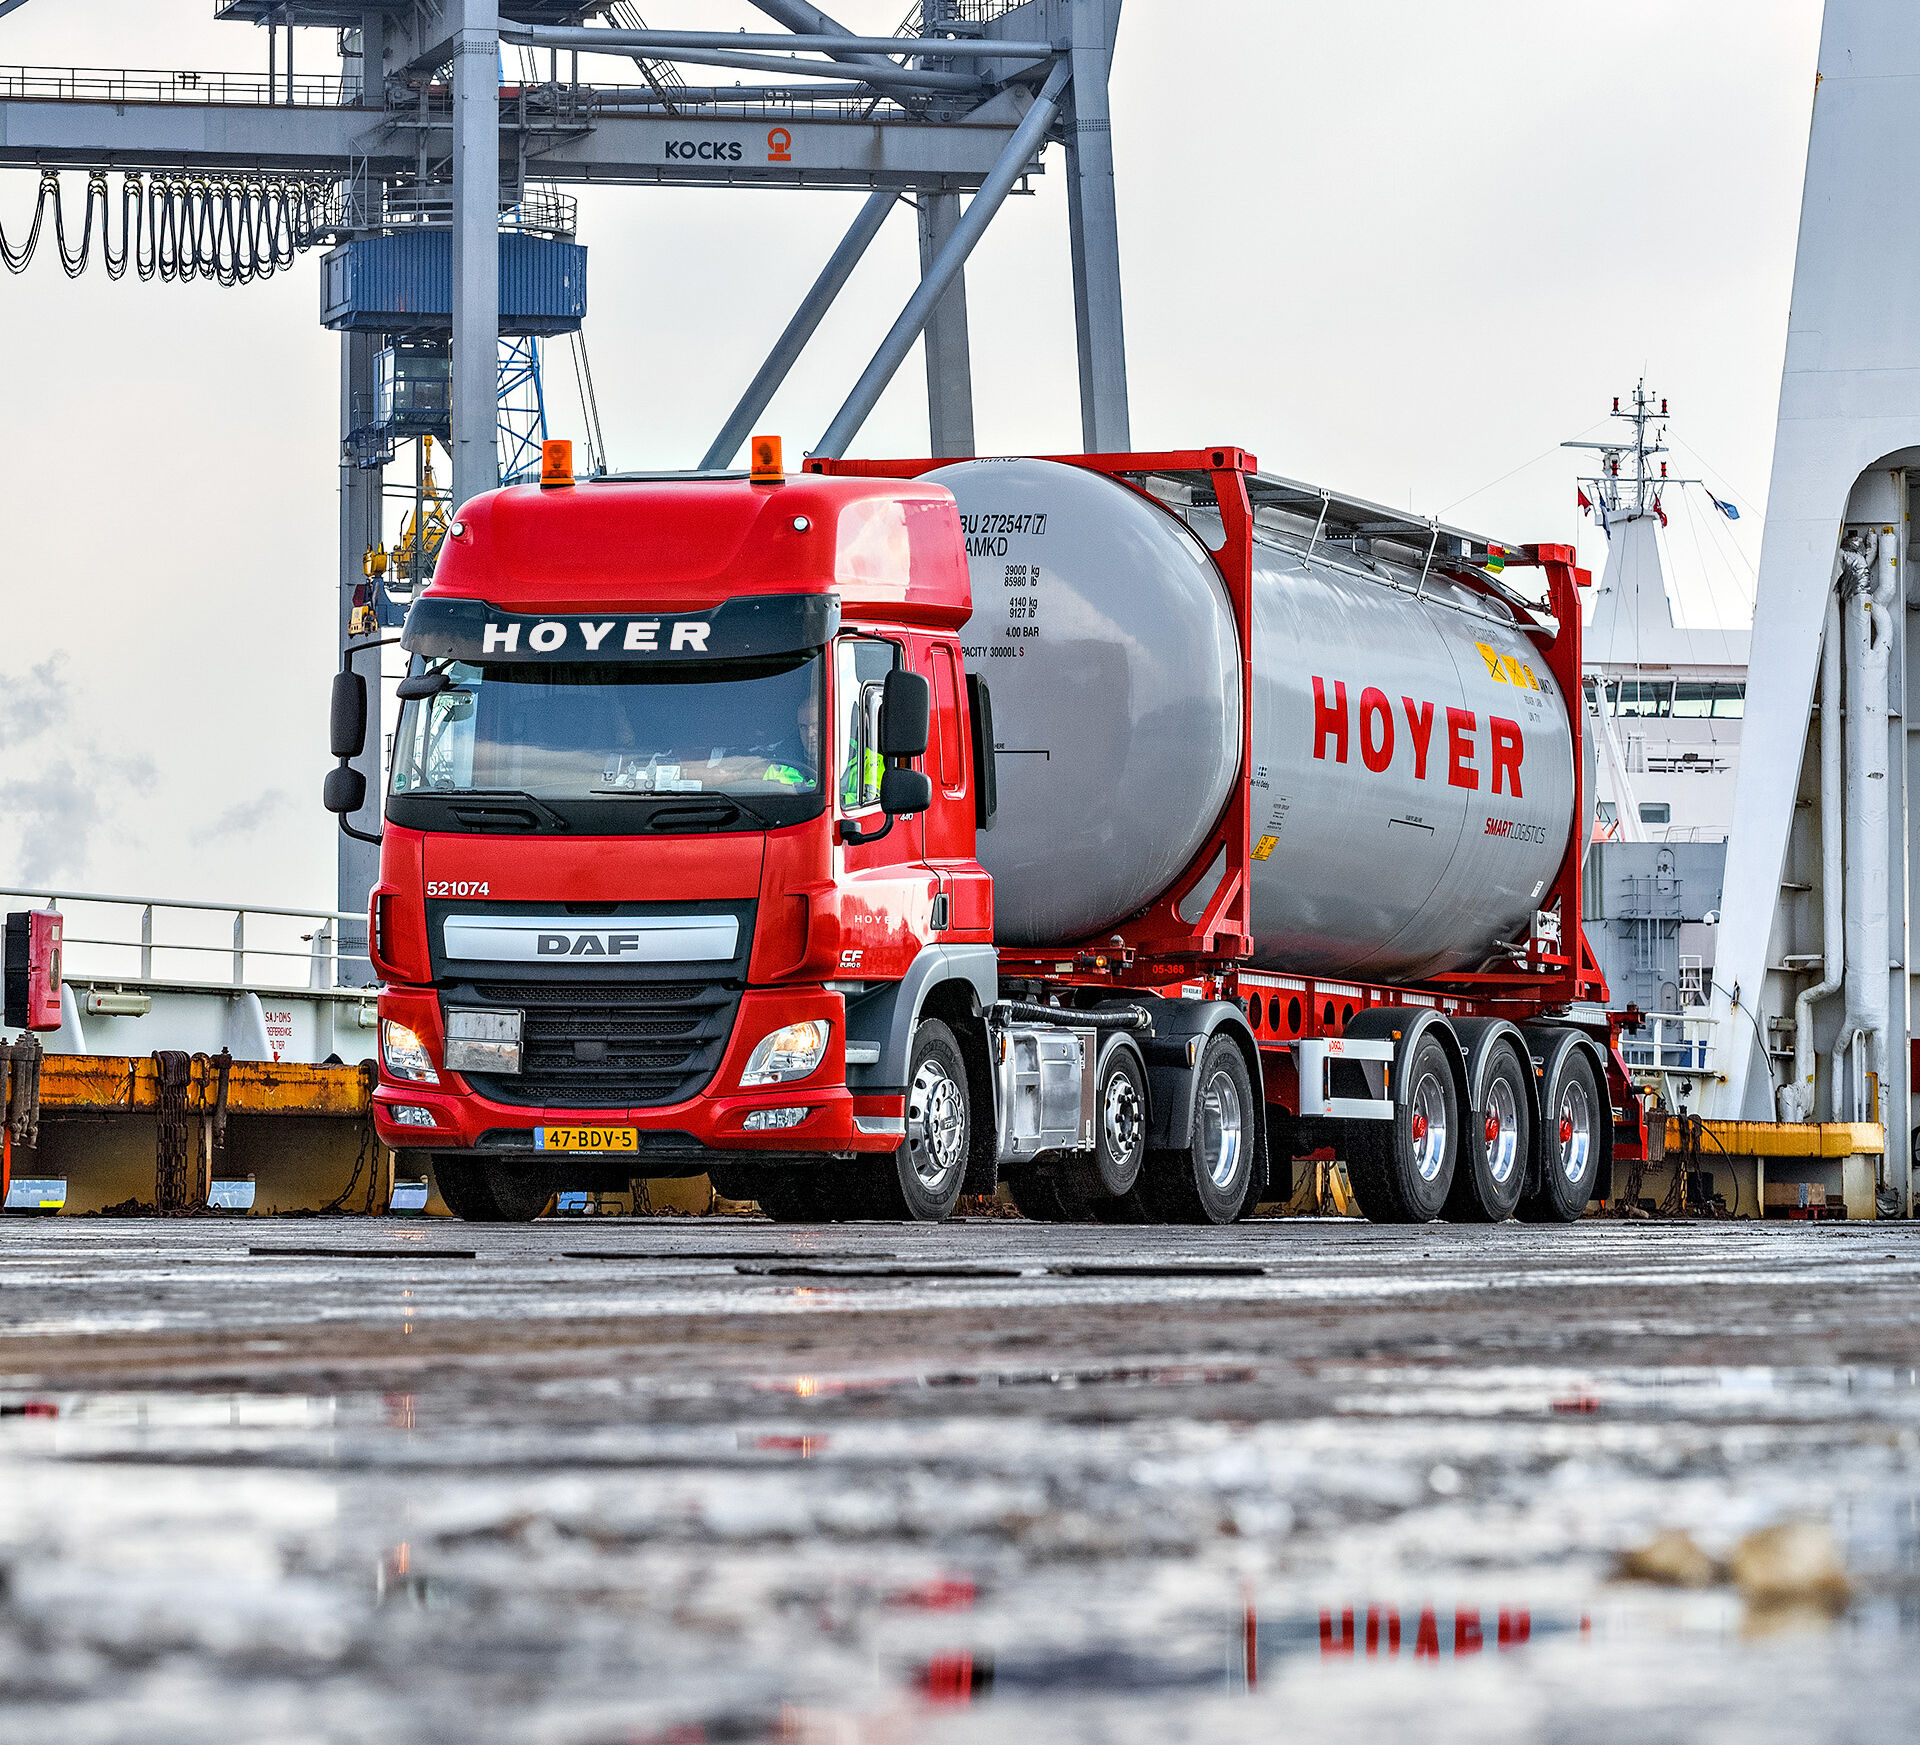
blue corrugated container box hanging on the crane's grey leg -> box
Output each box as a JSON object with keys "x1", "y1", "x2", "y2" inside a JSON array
[{"x1": 321, "y1": 230, "x2": 588, "y2": 336}]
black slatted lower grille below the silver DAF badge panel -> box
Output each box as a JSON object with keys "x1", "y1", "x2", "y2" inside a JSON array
[{"x1": 445, "y1": 981, "x2": 739, "y2": 1110}]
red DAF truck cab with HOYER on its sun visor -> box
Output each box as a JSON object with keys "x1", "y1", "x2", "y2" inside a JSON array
[{"x1": 349, "y1": 456, "x2": 996, "y2": 1219}]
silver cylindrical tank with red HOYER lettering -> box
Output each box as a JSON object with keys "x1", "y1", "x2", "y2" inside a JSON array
[{"x1": 929, "y1": 461, "x2": 1578, "y2": 981}]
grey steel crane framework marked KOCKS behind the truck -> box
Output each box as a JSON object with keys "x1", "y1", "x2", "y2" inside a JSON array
[{"x1": 0, "y1": 0, "x2": 1133, "y2": 950}]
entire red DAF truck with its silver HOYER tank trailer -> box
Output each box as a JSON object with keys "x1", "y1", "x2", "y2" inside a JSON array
[{"x1": 326, "y1": 442, "x2": 1640, "y2": 1223}]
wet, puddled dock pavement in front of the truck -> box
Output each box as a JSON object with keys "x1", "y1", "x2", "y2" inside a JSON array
[{"x1": 0, "y1": 1219, "x2": 1920, "y2": 1745}]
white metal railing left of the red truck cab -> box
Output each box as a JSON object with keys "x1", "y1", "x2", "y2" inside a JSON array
[{"x1": 0, "y1": 889, "x2": 372, "y2": 989}]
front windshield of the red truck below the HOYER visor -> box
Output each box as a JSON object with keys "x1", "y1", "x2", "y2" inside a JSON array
[{"x1": 392, "y1": 649, "x2": 824, "y2": 827}]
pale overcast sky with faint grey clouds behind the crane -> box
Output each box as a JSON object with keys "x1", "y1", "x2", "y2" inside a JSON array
[{"x1": 0, "y1": 0, "x2": 1820, "y2": 904}]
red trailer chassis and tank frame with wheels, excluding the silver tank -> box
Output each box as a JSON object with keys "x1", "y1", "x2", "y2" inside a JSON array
[{"x1": 806, "y1": 445, "x2": 1645, "y2": 1223}]
